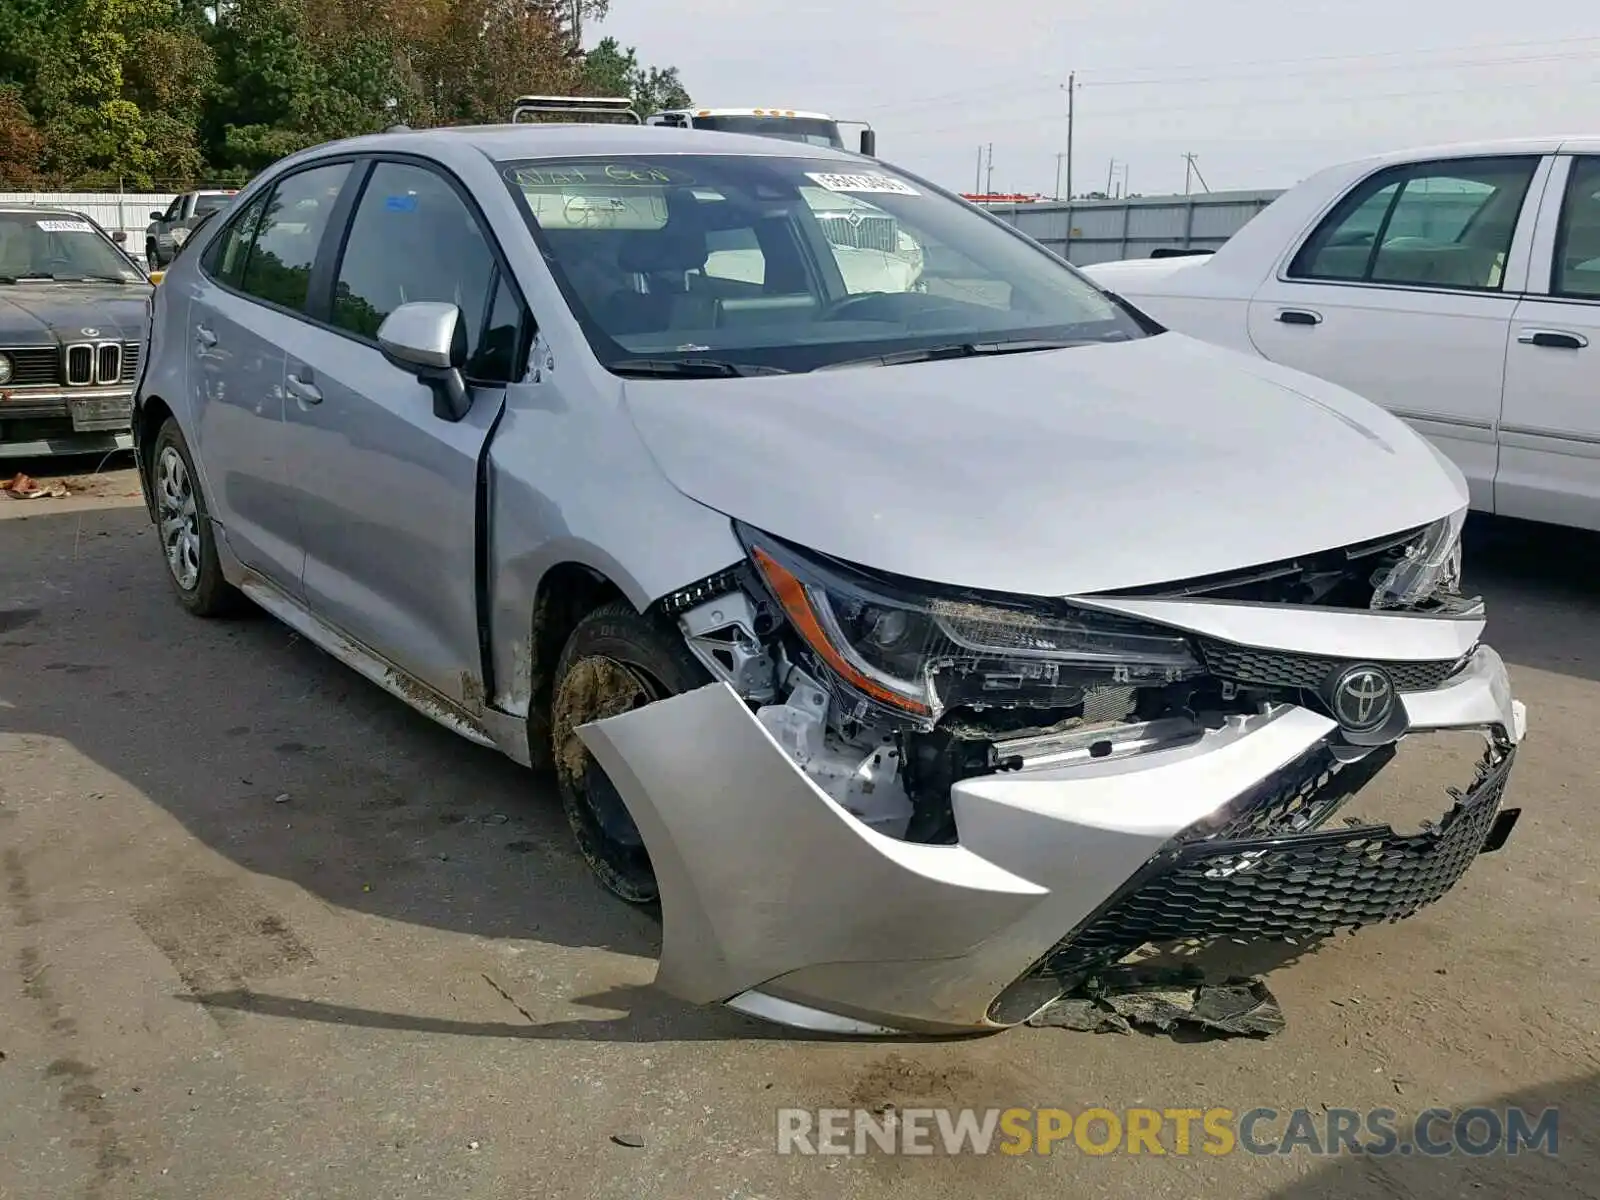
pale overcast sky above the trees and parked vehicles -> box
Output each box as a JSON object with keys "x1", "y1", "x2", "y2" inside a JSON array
[{"x1": 589, "y1": 0, "x2": 1600, "y2": 195}]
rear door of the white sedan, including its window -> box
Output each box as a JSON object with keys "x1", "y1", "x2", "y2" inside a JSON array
[{"x1": 1250, "y1": 154, "x2": 1549, "y2": 509}]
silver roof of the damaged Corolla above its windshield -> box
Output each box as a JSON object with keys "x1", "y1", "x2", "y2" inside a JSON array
[{"x1": 291, "y1": 122, "x2": 861, "y2": 162}]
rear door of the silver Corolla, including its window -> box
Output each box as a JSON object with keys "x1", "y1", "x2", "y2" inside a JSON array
[{"x1": 187, "y1": 163, "x2": 350, "y2": 595}]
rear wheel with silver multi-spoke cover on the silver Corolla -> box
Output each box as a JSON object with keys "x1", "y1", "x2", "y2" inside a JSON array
[{"x1": 150, "y1": 418, "x2": 243, "y2": 616}]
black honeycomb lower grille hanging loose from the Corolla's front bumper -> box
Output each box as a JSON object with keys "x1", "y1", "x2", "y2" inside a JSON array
[{"x1": 1032, "y1": 746, "x2": 1520, "y2": 987}]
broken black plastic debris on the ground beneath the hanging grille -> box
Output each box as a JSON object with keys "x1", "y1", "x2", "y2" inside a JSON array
[{"x1": 1027, "y1": 971, "x2": 1285, "y2": 1037}]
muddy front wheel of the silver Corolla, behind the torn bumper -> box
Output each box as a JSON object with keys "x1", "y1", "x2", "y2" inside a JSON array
[{"x1": 550, "y1": 600, "x2": 710, "y2": 906}]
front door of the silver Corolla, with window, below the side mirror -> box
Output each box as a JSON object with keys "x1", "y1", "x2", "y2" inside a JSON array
[{"x1": 275, "y1": 160, "x2": 526, "y2": 709}]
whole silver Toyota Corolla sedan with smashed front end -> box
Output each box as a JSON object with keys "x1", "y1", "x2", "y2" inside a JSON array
[{"x1": 136, "y1": 125, "x2": 1525, "y2": 1034}]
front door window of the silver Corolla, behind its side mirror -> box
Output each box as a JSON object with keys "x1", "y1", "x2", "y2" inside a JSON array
[{"x1": 333, "y1": 163, "x2": 515, "y2": 378}]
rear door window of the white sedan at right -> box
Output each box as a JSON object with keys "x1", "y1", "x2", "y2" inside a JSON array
[{"x1": 1290, "y1": 157, "x2": 1539, "y2": 291}]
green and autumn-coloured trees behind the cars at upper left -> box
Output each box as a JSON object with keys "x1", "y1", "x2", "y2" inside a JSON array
[{"x1": 0, "y1": 0, "x2": 688, "y2": 189}]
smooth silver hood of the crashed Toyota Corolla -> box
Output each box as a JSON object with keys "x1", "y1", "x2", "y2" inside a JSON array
[{"x1": 624, "y1": 333, "x2": 1467, "y2": 595}]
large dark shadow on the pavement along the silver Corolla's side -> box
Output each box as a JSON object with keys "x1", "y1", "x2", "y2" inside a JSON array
[{"x1": 0, "y1": 501, "x2": 659, "y2": 957}]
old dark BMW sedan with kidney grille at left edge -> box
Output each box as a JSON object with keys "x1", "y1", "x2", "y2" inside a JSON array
[{"x1": 0, "y1": 208, "x2": 150, "y2": 458}]
